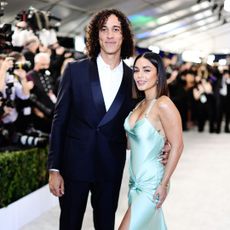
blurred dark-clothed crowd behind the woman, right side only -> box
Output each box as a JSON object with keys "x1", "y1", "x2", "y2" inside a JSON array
[{"x1": 165, "y1": 58, "x2": 230, "y2": 133}]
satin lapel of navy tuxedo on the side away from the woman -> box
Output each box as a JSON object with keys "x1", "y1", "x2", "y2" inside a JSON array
[{"x1": 89, "y1": 59, "x2": 106, "y2": 118}]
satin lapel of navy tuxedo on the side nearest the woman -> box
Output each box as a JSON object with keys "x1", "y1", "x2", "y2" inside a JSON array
[{"x1": 99, "y1": 63, "x2": 130, "y2": 126}]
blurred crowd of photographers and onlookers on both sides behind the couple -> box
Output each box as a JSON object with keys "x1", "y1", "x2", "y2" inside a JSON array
[{"x1": 0, "y1": 16, "x2": 230, "y2": 151}]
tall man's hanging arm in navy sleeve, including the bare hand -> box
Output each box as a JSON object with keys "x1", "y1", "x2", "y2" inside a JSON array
[{"x1": 48, "y1": 62, "x2": 71, "y2": 197}]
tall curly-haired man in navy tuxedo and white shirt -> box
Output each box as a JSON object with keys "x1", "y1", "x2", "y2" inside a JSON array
[{"x1": 48, "y1": 9, "x2": 168, "y2": 230}]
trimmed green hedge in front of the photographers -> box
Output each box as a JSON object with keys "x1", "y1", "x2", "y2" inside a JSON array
[{"x1": 0, "y1": 148, "x2": 48, "y2": 208}]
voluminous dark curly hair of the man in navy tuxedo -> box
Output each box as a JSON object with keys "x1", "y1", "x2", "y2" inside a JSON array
[{"x1": 86, "y1": 9, "x2": 134, "y2": 59}]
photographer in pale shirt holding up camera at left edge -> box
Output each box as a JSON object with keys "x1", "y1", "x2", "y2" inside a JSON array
[{"x1": 0, "y1": 52, "x2": 32, "y2": 144}]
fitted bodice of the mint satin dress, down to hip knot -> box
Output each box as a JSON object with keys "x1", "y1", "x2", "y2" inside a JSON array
[{"x1": 124, "y1": 101, "x2": 165, "y2": 194}]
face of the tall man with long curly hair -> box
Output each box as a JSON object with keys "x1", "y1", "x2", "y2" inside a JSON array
[{"x1": 99, "y1": 14, "x2": 123, "y2": 55}]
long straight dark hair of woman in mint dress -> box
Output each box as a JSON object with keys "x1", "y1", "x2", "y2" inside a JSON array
[{"x1": 133, "y1": 52, "x2": 169, "y2": 99}]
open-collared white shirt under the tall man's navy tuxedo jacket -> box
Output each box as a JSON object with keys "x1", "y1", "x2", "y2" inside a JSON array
[{"x1": 97, "y1": 54, "x2": 124, "y2": 111}]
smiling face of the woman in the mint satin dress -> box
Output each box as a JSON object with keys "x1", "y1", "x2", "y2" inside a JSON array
[{"x1": 134, "y1": 57, "x2": 158, "y2": 91}]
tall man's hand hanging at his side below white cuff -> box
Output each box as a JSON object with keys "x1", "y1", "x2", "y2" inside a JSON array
[{"x1": 49, "y1": 171, "x2": 64, "y2": 197}]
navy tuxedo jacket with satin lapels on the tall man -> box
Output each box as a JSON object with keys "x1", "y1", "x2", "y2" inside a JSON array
[{"x1": 48, "y1": 59, "x2": 133, "y2": 182}]
